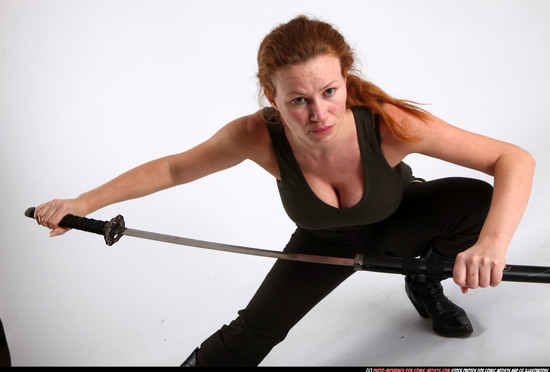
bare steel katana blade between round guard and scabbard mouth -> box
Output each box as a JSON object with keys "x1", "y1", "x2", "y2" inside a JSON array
[{"x1": 122, "y1": 228, "x2": 362, "y2": 267}]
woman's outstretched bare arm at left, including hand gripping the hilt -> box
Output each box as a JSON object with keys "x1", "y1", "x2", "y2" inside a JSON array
[{"x1": 35, "y1": 115, "x2": 272, "y2": 236}]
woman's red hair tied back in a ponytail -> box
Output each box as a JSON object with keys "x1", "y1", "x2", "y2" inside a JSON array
[{"x1": 257, "y1": 16, "x2": 428, "y2": 142}]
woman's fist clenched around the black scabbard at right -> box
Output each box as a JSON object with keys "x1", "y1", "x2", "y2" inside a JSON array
[{"x1": 453, "y1": 243, "x2": 506, "y2": 293}]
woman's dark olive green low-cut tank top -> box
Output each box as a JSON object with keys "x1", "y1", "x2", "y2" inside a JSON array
[{"x1": 266, "y1": 107, "x2": 413, "y2": 230}]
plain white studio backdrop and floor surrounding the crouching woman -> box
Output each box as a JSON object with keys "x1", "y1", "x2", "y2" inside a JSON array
[{"x1": 0, "y1": 0, "x2": 550, "y2": 366}]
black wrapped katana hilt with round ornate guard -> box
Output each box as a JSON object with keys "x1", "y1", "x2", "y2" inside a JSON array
[{"x1": 25, "y1": 207, "x2": 126, "y2": 246}]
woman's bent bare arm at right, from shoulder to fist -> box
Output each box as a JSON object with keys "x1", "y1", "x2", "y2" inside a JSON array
[{"x1": 383, "y1": 107, "x2": 535, "y2": 293}]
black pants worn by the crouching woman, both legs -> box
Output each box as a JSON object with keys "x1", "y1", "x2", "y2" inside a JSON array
[{"x1": 201, "y1": 178, "x2": 492, "y2": 366}]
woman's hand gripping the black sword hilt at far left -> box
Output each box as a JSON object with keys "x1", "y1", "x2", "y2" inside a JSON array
[{"x1": 34, "y1": 198, "x2": 88, "y2": 237}]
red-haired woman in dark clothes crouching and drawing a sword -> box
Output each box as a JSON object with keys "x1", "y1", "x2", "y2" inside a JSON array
[{"x1": 35, "y1": 16, "x2": 534, "y2": 366}]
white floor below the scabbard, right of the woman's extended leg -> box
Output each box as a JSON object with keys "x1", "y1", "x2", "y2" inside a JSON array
[{"x1": 262, "y1": 273, "x2": 550, "y2": 367}]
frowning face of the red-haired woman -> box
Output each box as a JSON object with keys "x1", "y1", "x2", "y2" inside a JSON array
[{"x1": 268, "y1": 55, "x2": 347, "y2": 145}]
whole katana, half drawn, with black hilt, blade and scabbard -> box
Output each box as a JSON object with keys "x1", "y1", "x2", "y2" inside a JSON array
[{"x1": 25, "y1": 207, "x2": 550, "y2": 283}]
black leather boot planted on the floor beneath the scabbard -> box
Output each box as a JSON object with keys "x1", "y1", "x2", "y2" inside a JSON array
[{"x1": 405, "y1": 276, "x2": 473, "y2": 337}]
